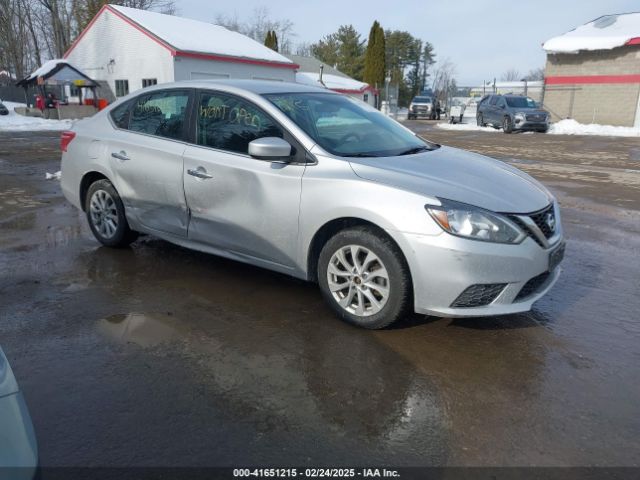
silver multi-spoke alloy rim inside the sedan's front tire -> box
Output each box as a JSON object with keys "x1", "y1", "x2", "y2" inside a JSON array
[{"x1": 327, "y1": 245, "x2": 390, "y2": 317}]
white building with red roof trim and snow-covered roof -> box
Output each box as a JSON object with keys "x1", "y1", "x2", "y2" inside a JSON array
[{"x1": 64, "y1": 5, "x2": 298, "y2": 97}]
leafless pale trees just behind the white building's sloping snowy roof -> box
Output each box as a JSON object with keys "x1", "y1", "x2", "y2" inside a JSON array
[{"x1": 214, "y1": 7, "x2": 295, "y2": 53}]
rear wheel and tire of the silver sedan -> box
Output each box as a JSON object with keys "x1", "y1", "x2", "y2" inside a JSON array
[{"x1": 85, "y1": 179, "x2": 138, "y2": 248}]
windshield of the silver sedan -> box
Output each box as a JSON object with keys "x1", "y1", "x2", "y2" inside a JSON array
[{"x1": 265, "y1": 93, "x2": 437, "y2": 157}]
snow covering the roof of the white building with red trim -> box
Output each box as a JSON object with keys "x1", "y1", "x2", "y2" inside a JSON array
[{"x1": 109, "y1": 5, "x2": 294, "y2": 65}]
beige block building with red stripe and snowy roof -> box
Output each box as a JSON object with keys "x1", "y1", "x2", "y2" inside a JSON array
[{"x1": 543, "y1": 13, "x2": 640, "y2": 127}]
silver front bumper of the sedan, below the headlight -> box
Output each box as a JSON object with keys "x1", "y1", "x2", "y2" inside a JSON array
[{"x1": 399, "y1": 228, "x2": 563, "y2": 317}]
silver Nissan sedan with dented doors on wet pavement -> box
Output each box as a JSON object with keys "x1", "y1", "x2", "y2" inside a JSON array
[{"x1": 61, "y1": 80, "x2": 564, "y2": 328}]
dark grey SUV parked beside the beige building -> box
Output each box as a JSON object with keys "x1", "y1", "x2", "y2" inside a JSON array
[{"x1": 476, "y1": 95, "x2": 549, "y2": 133}]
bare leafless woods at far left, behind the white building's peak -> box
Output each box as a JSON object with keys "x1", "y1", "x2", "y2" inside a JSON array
[{"x1": 0, "y1": 0, "x2": 175, "y2": 79}]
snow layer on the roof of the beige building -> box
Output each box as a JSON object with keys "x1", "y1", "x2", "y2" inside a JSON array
[{"x1": 542, "y1": 12, "x2": 640, "y2": 53}]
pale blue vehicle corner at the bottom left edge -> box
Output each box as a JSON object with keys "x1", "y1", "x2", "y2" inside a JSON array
[{"x1": 0, "y1": 348, "x2": 38, "y2": 480}]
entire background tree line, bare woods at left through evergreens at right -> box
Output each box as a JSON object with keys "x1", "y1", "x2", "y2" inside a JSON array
[{"x1": 0, "y1": 0, "x2": 455, "y2": 105}]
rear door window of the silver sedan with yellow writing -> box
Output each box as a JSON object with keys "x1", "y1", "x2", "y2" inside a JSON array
[{"x1": 129, "y1": 90, "x2": 189, "y2": 140}]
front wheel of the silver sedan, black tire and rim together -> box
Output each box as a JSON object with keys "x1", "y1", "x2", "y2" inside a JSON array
[{"x1": 318, "y1": 227, "x2": 412, "y2": 329}]
